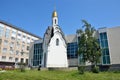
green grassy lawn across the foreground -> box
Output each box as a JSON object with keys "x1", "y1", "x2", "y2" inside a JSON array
[{"x1": 0, "y1": 70, "x2": 120, "y2": 80}]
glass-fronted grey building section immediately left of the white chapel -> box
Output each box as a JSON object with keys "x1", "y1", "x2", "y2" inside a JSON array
[{"x1": 29, "y1": 40, "x2": 43, "y2": 67}]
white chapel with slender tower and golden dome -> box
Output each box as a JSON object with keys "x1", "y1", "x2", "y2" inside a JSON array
[{"x1": 43, "y1": 11, "x2": 68, "y2": 68}]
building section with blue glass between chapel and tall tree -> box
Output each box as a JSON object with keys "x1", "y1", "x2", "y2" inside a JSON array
[{"x1": 65, "y1": 34, "x2": 78, "y2": 67}]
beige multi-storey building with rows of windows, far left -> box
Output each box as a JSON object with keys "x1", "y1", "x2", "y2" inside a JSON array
[{"x1": 0, "y1": 21, "x2": 41, "y2": 67}]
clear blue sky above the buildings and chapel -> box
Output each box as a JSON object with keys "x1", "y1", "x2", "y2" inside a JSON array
[{"x1": 0, "y1": 0, "x2": 120, "y2": 37}]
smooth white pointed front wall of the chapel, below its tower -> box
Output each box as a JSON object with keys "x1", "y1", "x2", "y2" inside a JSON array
[{"x1": 46, "y1": 27, "x2": 68, "y2": 67}]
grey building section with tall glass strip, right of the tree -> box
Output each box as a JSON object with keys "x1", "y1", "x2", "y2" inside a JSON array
[{"x1": 98, "y1": 27, "x2": 120, "y2": 70}]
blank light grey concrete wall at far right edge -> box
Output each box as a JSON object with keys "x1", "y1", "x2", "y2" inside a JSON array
[{"x1": 107, "y1": 27, "x2": 120, "y2": 64}]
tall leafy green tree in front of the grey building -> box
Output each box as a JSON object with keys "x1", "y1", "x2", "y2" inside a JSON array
[{"x1": 77, "y1": 20, "x2": 101, "y2": 72}]
